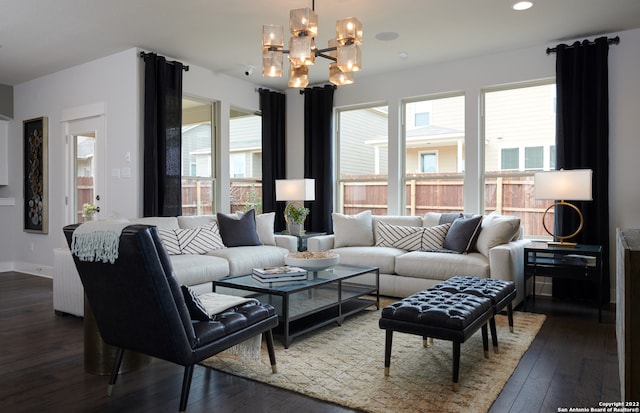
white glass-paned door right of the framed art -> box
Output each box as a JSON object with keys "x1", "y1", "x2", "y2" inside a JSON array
[{"x1": 62, "y1": 116, "x2": 107, "y2": 225}]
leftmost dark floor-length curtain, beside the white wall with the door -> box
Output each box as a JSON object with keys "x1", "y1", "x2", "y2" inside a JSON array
[{"x1": 141, "y1": 53, "x2": 187, "y2": 217}]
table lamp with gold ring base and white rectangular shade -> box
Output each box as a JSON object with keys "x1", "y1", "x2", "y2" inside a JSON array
[{"x1": 533, "y1": 169, "x2": 593, "y2": 247}]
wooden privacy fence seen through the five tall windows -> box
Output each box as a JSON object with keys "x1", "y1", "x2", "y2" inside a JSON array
[{"x1": 182, "y1": 176, "x2": 553, "y2": 236}]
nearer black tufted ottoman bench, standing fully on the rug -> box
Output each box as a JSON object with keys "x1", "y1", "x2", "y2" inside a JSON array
[{"x1": 378, "y1": 290, "x2": 493, "y2": 391}]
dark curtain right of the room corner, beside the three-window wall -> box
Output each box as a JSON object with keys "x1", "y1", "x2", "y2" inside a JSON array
[{"x1": 304, "y1": 85, "x2": 335, "y2": 233}]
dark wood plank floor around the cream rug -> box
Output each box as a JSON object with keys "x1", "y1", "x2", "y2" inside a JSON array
[{"x1": 0, "y1": 272, "x2": 620, "y2": 413}]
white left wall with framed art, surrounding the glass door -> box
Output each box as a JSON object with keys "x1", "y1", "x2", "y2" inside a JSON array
[{"x1": 0, "y1": 49, "x2": 140, "y2": 275}]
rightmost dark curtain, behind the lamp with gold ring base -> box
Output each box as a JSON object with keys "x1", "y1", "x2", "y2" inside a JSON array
[{"x1": 553, "y1": 37, "x2": 610, "y2": 302}]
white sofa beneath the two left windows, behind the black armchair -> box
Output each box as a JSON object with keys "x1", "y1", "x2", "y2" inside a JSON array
[{"x1": 53, "y1": 213, "x2": 298, "y2": 316}]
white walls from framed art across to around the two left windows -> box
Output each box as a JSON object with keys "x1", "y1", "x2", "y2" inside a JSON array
[{"x1": 0, "y1": 48, "x2": 259, "y2": 276}]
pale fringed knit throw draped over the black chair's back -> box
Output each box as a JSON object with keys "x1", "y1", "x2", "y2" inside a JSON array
[{"x1": 71, "y1": 221, "x2": 129, "y2": 264}]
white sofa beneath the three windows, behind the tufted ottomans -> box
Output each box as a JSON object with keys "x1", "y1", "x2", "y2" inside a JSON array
[{"x1": 307, "y1": 211, "x2": 530, "y2": 306}]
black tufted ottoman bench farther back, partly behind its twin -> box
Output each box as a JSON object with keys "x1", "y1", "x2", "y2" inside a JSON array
[{"x1": 430, "y1": 276, "x2": 516, "y2": 353}]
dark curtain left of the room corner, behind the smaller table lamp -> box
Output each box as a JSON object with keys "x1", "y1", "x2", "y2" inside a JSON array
[{"x1": 259, "y1": 89, "x2": 287, "y2": 231}]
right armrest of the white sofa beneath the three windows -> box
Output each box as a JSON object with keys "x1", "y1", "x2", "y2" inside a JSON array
[{"x1": 489, "y1": 239, "x2": 531, "y2": 307}]
